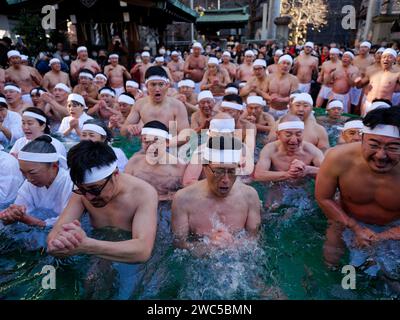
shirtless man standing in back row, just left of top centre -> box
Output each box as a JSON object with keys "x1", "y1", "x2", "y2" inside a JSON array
[{"x1": 183, "y1": 42, "x2": 207, "y2": 93}]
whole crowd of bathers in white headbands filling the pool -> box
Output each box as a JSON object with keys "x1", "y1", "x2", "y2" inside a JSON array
[{"x1": 0, "y1": 36, "x2": 400, "y2": 288}]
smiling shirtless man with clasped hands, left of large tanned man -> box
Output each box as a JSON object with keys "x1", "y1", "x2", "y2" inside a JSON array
[{"x1": 254, "y1": 115, "x2": 324, "y2": 182}]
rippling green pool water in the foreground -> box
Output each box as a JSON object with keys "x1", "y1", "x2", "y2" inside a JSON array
[{"x1": 0, "y1": 129, "x2": 396, "y2": 300}]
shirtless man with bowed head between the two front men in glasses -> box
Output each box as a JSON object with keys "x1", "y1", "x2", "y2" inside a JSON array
[{"x1": 125, "y1": 121, "x2": 186, "y2": 201}]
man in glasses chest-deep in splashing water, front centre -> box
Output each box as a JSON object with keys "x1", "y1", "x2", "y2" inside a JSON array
[{"x1": 171, "y1": 137, "x2": 261, "y2": 250}]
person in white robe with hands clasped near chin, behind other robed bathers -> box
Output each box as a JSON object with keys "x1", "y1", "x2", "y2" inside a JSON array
[{"x1": 58, "y1": 93, "x2": 93, "y2": 140}]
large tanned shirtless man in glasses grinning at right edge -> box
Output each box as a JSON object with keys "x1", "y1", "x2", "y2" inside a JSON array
[{"x1": 315, "y1": 107, "x2": 400, "y2": 276}]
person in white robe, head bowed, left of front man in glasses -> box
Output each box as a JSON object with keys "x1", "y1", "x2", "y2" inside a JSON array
[{"x1": 0, "y1": 135, "x2": 73, "y2": 227}]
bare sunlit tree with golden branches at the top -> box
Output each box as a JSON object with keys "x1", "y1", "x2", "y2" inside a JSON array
[{"x1": 281, "y1": 0, "x2": 328, "y2": 44}]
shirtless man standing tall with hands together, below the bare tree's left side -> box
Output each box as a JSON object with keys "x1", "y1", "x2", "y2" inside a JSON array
[{"x1": 263, "y1": 55, "x2": 299, "y2": 119}]
